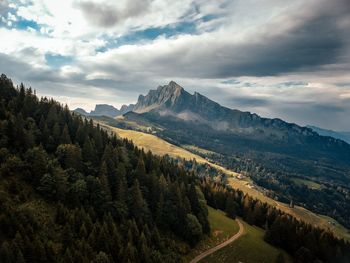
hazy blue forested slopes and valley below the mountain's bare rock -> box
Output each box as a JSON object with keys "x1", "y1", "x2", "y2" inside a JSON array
[{"x1": 146, "y1": 113, "x2": 350, "y2": 231}]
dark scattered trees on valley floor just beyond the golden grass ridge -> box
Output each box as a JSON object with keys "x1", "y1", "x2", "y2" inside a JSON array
[{"x1": 191, "y1": 152, "x2": 350, "y2": 231}]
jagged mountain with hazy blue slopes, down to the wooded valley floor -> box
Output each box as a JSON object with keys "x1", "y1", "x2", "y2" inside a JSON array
[{"x1": 119, "y1": 81, "x2": 350, "y2": 181}]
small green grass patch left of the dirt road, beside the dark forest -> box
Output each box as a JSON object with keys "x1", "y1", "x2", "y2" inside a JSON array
[{"x1": 185, "y1": 206, "x2": 239, "y2": 261}]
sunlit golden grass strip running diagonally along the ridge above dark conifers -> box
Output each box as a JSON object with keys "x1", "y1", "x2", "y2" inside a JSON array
[{"x1": 101, "y1": 123, "x2": 350, "y2": 240}]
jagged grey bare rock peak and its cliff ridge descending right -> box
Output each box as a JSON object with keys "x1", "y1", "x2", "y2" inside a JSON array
[{"x1": 129, "y1": 81, "x2": 314, "y2": 138}]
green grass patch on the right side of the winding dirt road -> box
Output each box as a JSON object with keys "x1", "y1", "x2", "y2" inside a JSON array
[{"x1": 201, "y1": 222, "x2": 292, "y2": 263}]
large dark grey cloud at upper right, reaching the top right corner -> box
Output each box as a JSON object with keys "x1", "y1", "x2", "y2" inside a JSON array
[{"x1": 215, "y1": 0, "x2": 350, "y2": 77}]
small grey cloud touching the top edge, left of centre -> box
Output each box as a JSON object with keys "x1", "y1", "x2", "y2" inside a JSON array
[{"x1": 78, "y1": 0, "x2": 149, "y2": 28}]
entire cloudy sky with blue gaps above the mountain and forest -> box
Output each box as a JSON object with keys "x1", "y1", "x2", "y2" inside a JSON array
[{"x1": 0, "y1": 0, "x2": 350, "y2": 130}]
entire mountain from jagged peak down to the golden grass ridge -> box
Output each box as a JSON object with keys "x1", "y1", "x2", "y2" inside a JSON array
[{"x1": 118, "y1": 82, "x2": 350, "y2": 227}]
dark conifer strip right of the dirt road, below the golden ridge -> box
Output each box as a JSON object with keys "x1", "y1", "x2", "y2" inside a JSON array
[{"x1": 201, "y1": 178, "x2": 350, "y2": 263}]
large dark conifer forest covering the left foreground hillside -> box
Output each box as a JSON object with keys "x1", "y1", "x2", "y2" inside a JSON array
[{"x1": 0, "y1": 75, "x2": 210, "y2": 263}]
